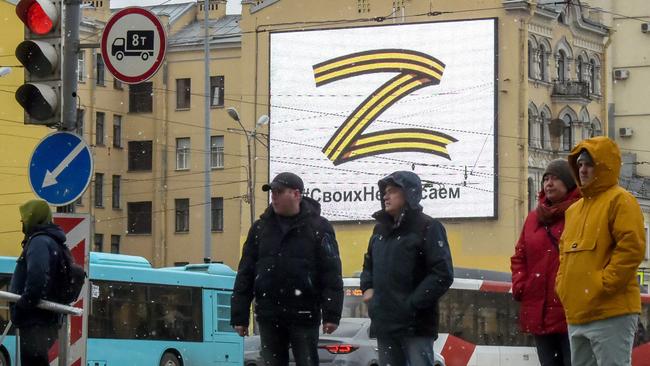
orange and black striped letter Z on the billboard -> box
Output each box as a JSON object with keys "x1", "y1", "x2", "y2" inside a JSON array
[{"x1": 313, "y1": 49, "x2": 457, "y2": 165}]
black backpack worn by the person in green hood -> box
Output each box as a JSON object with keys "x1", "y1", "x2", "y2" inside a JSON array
[{"x1": 25, "y1": 232, "x2": 86, "y2": 305}]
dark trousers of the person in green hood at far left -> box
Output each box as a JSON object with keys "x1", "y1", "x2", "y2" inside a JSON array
[{"x1": 19, "y1": 324, "x2": 59, "y2": 366}]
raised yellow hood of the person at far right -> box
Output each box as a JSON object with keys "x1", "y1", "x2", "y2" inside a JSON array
[{"x1": 568, "y1": 136, "x2": 621, "y2": 197}]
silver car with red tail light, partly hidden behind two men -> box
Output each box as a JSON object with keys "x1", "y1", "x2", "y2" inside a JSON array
[{"x1": 244, "y1": 318, "x2": 445, "y2": 366}]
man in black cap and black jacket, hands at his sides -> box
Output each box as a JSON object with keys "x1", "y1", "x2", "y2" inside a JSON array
[{"x1": 231, "y1": 173, "x2": 343, "y2": 366}]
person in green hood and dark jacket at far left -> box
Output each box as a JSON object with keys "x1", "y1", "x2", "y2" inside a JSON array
[{"x1": 9, "y1": 200, "x2": 66, "y2": 366}]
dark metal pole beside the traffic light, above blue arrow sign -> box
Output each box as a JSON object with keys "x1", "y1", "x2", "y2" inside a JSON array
[{"x1": 61, "y1": 0, "x2": 81, "y2": 131}]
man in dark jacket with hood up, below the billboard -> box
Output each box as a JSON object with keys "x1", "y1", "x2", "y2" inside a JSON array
[{"x1": 361, "y1": 171, "x2": 454, "y2": 366}]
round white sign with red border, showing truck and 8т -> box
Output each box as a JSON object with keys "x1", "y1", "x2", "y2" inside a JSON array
[{"x1": 101, "y1": 7, "x2": 167, "y2": 84}]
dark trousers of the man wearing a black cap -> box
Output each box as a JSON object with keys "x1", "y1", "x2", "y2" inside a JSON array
[{"x1": 259, "y1": 322, "x2": 319, "y2": 366}]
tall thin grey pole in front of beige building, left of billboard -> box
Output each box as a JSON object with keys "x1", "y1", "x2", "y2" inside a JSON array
[{"x1": 203, "y1": 0, "x2": 212, "y2": 261}]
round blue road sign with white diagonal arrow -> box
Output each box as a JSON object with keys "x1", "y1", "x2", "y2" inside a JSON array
[{"x1": 29, "y1": 132, "x2": 93, "y2": 206}]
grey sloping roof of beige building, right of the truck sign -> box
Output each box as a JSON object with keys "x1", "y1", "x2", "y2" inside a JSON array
[{"x1": 168, "y1": 15, "x2": 241, "y2": 47}]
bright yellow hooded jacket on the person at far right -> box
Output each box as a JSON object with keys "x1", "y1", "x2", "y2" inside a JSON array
[{"x1": 555, "y1": 136, "x2": 645, "y2": 324}]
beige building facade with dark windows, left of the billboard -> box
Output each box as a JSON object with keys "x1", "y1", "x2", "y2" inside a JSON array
[{"x1": 71, "y1": 1, "x2": 252, "y2": 266}]
